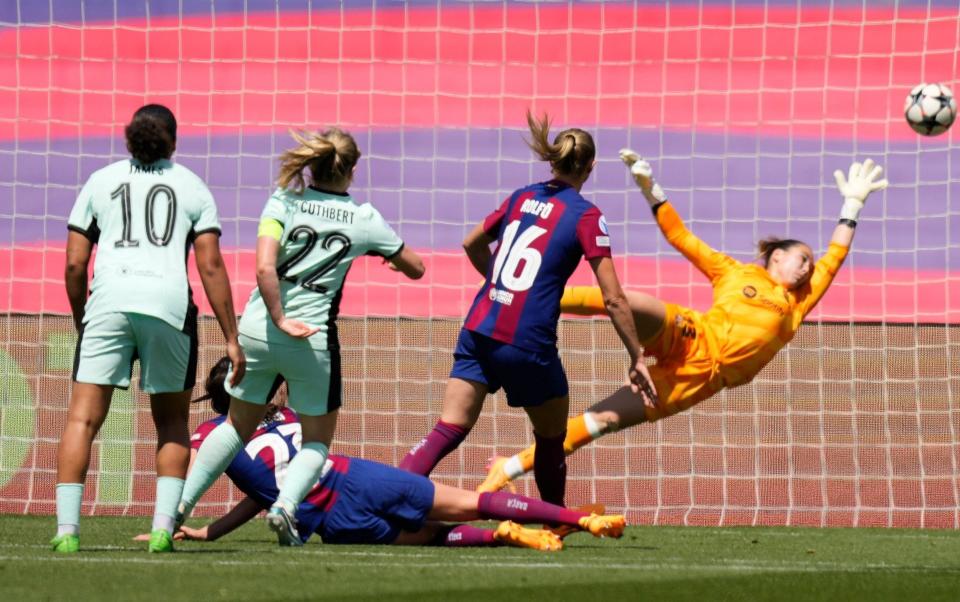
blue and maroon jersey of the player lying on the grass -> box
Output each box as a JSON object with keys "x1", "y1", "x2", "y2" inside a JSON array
[{"x1": 190, "y1": 408, "x2": 350, "y2": 541}]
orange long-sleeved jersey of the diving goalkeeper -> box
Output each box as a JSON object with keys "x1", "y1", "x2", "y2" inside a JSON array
[{"x1": 657, "y1": 203, "x2": 847, "y2": 387}]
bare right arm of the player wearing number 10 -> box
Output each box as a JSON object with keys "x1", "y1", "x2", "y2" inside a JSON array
[{"x1": 193, "y1": 232, "x2": 247, "y2": 385}]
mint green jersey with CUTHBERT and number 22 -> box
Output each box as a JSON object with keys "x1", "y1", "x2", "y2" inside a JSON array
[{"x1": 240, "y1": 188, "x2": 403, "y2": 349}]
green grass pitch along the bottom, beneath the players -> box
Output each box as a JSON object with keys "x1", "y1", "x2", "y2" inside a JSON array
[{"x1": 0, "y1": 515, "x2": 960, "y2": 602}]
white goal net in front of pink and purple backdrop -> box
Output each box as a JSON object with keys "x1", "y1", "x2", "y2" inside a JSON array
[{"x1": 0, "y1": 0, "x2": 960, "y2": 528}]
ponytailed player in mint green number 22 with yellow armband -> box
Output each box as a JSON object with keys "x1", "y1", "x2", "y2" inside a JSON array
[{"x1": 179, "y1": 128, "x2": 424, "y2": 545}]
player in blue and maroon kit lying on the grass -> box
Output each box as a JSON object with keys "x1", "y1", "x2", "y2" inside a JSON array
[{"x1": 170, "y1": 358, "x2": 625, "y2": 551}]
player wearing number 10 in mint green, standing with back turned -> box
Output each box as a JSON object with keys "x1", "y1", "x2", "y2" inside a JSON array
[{"x1": 50, "y1": 105, "x2": 245, "y2": 552}]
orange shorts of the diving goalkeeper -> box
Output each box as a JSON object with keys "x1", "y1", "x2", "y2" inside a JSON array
[{"x1": 644, "y1": 303, "x2": 723, "y2": 422}]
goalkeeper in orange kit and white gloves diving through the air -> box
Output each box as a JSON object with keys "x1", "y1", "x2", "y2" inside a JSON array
[{"x1": 478, "y1": 149, "x2": 887, "y2": 491}]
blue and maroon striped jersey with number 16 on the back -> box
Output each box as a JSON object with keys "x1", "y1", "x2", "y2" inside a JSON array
[{"x1": 464, "y1": 180, "x2": 610, "y2": 351}]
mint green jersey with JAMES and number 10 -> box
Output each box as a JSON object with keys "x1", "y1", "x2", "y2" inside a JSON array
[{"x1": 67, "y1": 159, "x2": 220, "y2": 329}]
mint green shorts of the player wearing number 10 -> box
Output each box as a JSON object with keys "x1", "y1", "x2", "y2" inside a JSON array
[{"x1": 73, "y1": 311, "x2": 197, "y2": 394}]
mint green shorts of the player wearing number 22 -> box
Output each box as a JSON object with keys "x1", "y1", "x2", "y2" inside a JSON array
[{"x1": 224, "y1": 334, "x2": 342, "y2": 416}]
